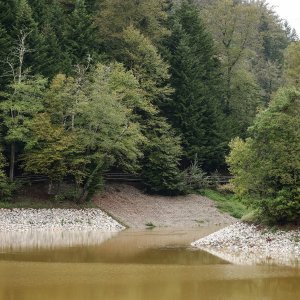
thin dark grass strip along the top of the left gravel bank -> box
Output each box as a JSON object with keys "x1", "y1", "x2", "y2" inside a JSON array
[{"x1": 0, "y1": 197, "x2": 97, "y2": 209}]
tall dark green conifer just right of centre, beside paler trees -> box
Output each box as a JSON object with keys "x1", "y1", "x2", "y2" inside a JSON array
[{"x1": 164, "y1": 1, "x2": 223, "y2": 169}]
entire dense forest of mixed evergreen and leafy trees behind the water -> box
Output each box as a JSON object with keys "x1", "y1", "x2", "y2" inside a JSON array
[{"x1": 0, "y1": 0, "x2": 300, "y2": 222}]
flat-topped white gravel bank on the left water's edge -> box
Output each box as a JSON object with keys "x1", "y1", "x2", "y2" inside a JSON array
[{"x1": 0, "y1": 209, "x2": 124, "y2": 233}]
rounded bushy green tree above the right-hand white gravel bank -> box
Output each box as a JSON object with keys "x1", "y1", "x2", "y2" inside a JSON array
[{"x1": 227, "y1": 88, "x2": 300, "y2": 223}]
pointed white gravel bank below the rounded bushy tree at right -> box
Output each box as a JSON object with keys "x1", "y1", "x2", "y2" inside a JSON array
[{"x1": 192, "y1": 222, "x2": 300, "y2": 267}]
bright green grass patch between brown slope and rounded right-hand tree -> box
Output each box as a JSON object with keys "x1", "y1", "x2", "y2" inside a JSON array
[{"x1": 201, "y1": 189, "x2": 250, "y2": 219}]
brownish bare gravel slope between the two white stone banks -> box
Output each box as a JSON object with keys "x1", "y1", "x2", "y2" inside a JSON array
[{"x1": 94, "y1": 184, "x2": 236, "y2": 228}]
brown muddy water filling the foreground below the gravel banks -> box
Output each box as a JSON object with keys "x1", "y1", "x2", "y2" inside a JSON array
[{"x1": 0, "y1": 228, "x2": 300, "y2": 300}]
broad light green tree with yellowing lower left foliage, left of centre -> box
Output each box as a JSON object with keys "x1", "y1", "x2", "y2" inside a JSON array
[{"x1": 33, "y1": 63, "x2": 146, "y2": 198}]
